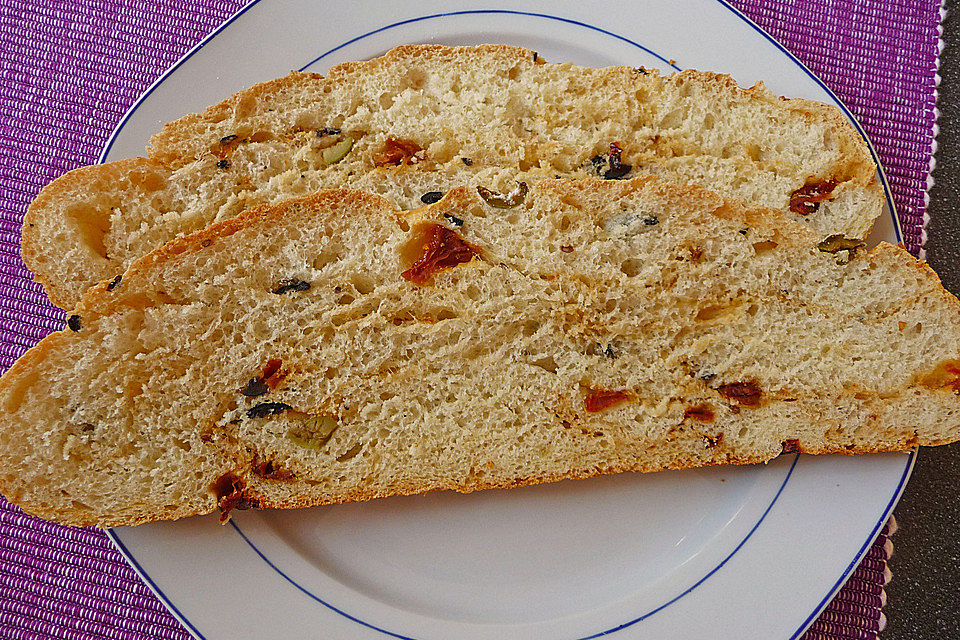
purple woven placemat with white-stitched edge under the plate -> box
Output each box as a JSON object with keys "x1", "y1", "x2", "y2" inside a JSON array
[{"x1": 0, "y1": 0, "x2": 941, "y2": 640}]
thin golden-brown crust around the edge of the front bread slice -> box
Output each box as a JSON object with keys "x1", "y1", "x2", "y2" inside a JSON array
[{"x1": 0, "y1": 177, "x2": 944, "y2": 526}]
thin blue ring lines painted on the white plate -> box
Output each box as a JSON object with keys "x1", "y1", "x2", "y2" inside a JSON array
[{"x1": 98, "y1": 0, "x2": 916, "y2": 640}]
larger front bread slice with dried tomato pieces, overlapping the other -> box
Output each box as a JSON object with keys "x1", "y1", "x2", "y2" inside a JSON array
[{"x1": 0, "y1": 177, "x2": 960, "y2": 526}]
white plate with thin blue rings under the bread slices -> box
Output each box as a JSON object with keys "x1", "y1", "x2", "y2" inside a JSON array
[{"x1": 103, "y1": 0, "x2": 914, "y2": 640}]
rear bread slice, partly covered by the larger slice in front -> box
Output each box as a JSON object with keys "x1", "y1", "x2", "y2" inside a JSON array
[{"x1": 23, "y1": 45, "x2": 882, "y2": 309}]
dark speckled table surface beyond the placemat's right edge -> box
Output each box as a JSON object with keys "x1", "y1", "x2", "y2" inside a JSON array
[{"x1": 881, "y1": 0, "x2": 960, "y2": 640}]
